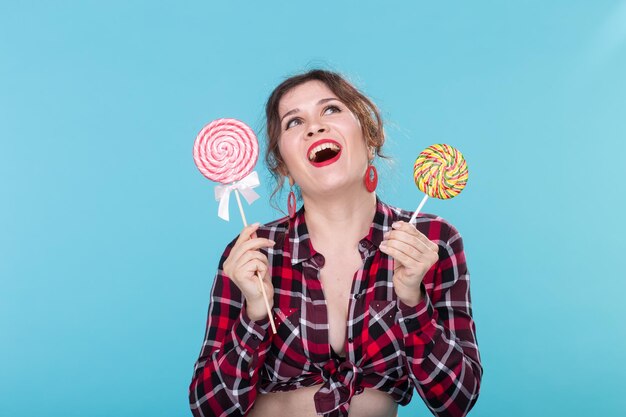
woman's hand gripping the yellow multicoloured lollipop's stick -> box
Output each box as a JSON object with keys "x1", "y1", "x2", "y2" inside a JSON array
[{"x1": 380, "y1": 222, "x2": 439, "y2": 307}]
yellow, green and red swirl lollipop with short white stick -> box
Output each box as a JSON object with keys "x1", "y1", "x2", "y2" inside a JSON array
[{"x1": 409, "y1": 144, "x2": 469, "y2": 222}]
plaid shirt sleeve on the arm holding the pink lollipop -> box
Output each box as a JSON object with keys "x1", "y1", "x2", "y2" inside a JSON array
[{"x1": 189, "y1": 242, "x2": 270, "y2": 417}]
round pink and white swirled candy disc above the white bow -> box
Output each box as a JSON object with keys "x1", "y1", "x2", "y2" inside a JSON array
[{"x1": 193, "y1": 119, "x2": 259, "y2": 184}]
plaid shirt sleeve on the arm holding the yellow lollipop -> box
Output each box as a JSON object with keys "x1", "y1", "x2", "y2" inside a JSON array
[{"x1": 398, "y1": 226, "x2": 483, "y2": 417}]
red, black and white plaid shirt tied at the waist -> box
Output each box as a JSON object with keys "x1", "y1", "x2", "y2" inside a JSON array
[{"x1": 189, "y1": 200, "x2": 482, "y2": 417}]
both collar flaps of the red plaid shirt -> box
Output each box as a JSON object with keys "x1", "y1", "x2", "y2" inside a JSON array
[{"x1": 288, "y1": 196, "x2": 399, "y2": 265}]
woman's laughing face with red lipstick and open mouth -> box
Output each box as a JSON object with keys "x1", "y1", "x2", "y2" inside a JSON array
[{"x1": 278, "y1": 81, "x2": 373, "y2": 195}]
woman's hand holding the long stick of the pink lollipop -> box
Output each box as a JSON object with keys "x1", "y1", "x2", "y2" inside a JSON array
[{"x1": 223, "y1": 223, "x2": 276, "y2": 321}]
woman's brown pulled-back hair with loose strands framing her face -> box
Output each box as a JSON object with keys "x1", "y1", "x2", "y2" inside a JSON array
[{"x1": 265, "y1": 69, "x2": 385, "y2": 206}]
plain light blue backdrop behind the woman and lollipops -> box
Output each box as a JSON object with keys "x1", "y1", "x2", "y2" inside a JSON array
[{"x1": 0, "y1": 0, "x2": 626, "y2": 417}]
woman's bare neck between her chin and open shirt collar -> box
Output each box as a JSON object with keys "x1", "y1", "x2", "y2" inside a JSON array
[{"x1": 302, "y1": 190, "x2": 376, "y2": 252}]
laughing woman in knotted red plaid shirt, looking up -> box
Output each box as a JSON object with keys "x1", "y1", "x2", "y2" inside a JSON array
[{"x1": 189, "y1": 70, "x2": 482, "y2": 417}]
